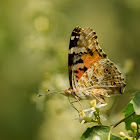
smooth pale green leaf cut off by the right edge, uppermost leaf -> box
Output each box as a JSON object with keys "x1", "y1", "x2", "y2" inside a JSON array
[{"x1": 131, "y1": 92, "x2": 140, "y2": 115}]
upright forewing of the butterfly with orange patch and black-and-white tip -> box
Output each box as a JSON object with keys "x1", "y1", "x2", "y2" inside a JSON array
[{"x1": 68, "y1": 27, "x2": 107, "y2": 88}]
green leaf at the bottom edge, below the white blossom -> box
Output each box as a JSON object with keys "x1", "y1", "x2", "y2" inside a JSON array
[{"x1": 81, "y1": 125, "x2": 121, "y2": 140}]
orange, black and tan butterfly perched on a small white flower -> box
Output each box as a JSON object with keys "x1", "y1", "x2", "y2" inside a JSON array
[{"x1": 63, "y1": 26, "x2": 126, "y2": 103}]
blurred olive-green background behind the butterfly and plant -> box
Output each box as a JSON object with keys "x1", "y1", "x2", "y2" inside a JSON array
[{"x1": 0, "y1": 0, "x2": 140, "y2": 140}]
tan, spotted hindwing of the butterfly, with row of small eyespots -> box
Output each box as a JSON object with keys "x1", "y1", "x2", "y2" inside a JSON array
[{"x1": 77, "y1": 59, "x2": 126, "y2": 96}]
